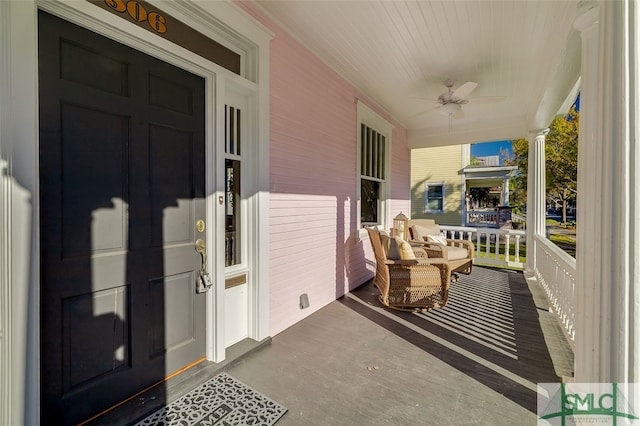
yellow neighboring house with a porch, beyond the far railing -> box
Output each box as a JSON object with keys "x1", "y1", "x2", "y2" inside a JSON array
[{"x1": 411, "y1": 144, "x2": 517, "y2": 227}]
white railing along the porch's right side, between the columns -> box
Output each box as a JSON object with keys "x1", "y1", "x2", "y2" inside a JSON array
[{"x1": 535, "y1": 236, "x2": 577, "y2": 346}]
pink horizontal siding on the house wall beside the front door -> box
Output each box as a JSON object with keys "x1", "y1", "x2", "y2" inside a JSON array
[{"x1": 235, "y1": 3, "x2": 410, "y2": 335}]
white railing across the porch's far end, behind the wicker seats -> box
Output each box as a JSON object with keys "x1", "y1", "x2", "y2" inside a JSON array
[{"x1": 440, "y1": 225, "x2": 526, "y2": 269}]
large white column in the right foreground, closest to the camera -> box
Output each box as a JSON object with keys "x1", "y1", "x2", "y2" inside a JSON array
[{"x1": 575, "y1": 1, "x2": 640, "y2": 384}]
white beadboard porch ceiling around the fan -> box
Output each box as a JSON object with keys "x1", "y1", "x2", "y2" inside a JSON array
[{"x1": 254, "y1": 0, "x2": 580, "y2": 148}]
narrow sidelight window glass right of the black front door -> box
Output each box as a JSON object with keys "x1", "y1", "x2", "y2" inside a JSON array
[{"x1": 224, "y1": 105, "x2": 242, "y2": 266}]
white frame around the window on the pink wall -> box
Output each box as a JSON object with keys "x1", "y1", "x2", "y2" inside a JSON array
[{"x1": 356, "y1": 101, "x2": 393, "y2": 239}]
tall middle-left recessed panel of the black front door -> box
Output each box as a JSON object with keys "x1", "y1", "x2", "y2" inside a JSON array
[{"x1": 60, "y1": 103, "x2": 129, "y2": 259}]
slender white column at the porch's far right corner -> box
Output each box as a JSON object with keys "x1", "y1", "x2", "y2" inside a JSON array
[{"x1": 527, "y1": 129, "x2": 549, "y2": 272}]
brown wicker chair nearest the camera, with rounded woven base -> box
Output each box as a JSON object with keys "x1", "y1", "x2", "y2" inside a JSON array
[{"x1": 367, "y1": 228, "x2": 451, "y2": 311}]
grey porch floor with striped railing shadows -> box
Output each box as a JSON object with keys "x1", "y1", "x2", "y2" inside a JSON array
[{"x1": 95, "y1": 267, "x2": 573, "y2": 426}]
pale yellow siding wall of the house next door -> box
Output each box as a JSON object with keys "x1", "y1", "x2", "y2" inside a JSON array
[{"x1": 411, "y1": 145, "x2": 465, "y2": 225}]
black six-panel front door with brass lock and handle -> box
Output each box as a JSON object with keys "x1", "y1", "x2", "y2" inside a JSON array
[{"x1": 39, "y1": 12, "x2": 205, "y2": 424}]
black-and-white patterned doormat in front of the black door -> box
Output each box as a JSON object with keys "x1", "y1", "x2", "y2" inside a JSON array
[{"x1": 135, "y1": 373, "x2": 287, "y2": 426}]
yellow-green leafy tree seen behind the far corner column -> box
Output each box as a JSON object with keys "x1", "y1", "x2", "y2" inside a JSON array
[{"x1": 505, "y1": 107, "x2": 580, "y2": 223}]
